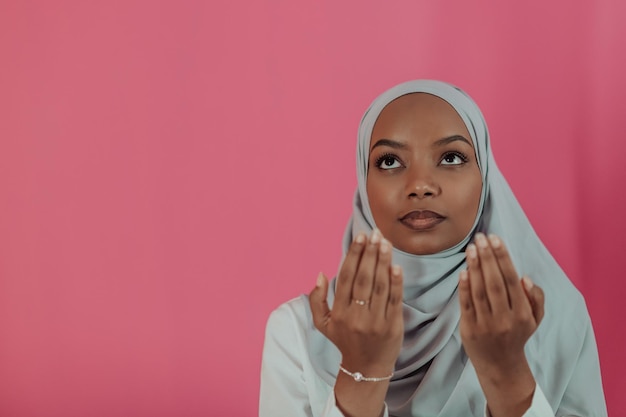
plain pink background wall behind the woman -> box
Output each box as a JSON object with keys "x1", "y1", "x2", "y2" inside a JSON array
[{"x1": 0, "y1": 0, "x2": 626, "y2": 417}]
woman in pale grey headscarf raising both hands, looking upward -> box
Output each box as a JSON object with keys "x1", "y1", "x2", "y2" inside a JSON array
[{"x1": 260, "y1": 80, "x2": 606, "y2": 417}]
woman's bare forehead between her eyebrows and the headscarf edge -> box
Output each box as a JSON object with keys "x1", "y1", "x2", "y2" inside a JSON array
[{"x1": 371, "y1": 93, "x2": 470, "y2": 146}]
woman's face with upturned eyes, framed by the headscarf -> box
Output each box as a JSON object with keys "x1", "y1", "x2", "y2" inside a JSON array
[{"x1": 367, "y1": 93, "x2": 482, "y2": 255}]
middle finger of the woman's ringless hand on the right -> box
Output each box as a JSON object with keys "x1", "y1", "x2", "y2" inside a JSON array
[{"x1": 475, "y1": 233, "x2": 510, "y2": 315}]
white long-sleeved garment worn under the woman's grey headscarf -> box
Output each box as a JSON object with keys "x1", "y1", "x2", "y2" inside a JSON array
[{"x1": 259, "y1": 295, "x2": 555, "y2": 417}]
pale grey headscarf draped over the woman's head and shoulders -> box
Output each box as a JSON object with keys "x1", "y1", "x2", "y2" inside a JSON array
[{"x1": 310, "y1": 80, "x2": 606, "y2": 417}]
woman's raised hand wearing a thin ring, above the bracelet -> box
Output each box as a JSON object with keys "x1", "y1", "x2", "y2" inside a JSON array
[{"x1": 309, "y1": 230, "x2": 404, "y2": 377}]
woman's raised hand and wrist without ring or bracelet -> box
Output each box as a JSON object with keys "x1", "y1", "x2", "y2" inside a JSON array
[{"x1": 459, "y1": 233, "x2": 544, "y2": 417}]
